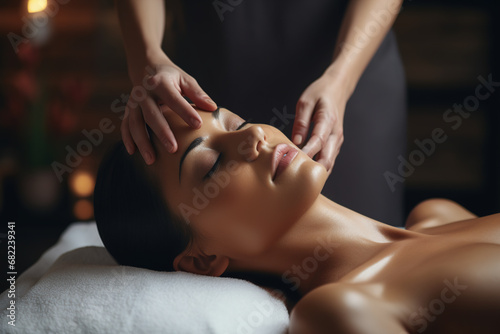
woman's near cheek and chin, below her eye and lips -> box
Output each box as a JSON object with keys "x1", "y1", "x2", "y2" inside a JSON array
[{"x1": 186, "y1": 155, "x2": 326, "y2": 258}]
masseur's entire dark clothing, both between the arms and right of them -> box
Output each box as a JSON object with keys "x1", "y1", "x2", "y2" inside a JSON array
[{"x1": 169, "y1": 0, "x2": 406, "y2": 225}]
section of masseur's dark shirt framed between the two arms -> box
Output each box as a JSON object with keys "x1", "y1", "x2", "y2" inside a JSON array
[{"x1": 174, "y1": 0, "x2": 346, "y2": 128}]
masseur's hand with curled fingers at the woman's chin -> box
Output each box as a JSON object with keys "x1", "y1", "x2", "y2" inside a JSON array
[{"x1": 292, "y1": 73, "x2": 347, "y2": 173}]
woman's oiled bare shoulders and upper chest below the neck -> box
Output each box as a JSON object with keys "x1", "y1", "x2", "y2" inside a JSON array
[{"x1": 289, "y1": 200, "x2": 500, "y2": 334}]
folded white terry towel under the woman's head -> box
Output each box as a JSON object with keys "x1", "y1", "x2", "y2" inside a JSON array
[{"x1": 0, "y1": 224, "x2": 289, "y2": 334}]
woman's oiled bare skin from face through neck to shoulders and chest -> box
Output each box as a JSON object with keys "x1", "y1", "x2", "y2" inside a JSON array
[{"x1": 143, "y1": 109, "x2": 500, "y2": 334}]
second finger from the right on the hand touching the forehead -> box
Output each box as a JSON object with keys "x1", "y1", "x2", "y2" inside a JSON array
[{"x1": 153, "y1": 82, "x2": 201, "y2": 129}]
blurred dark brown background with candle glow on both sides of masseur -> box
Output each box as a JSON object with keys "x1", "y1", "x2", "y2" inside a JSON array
[{"x1": 0, "y1": 0, "x2": 500, "y2": 290}]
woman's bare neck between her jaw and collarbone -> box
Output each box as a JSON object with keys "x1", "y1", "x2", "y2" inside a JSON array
[{"x1": 228, "y1": 195, "x2": 412, "y2": 295}]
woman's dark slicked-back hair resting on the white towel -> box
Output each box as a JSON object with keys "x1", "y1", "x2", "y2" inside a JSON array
[{"x1": 94, "y1": 141, "x2": 192, "y2": 271}]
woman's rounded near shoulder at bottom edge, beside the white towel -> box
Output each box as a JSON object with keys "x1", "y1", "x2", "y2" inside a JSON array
[{"x1": 289, "y1": 283, "x2": 406, "y2": 334}]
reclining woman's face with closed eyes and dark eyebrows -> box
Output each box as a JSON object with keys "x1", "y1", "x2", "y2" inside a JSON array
[{"x1": 150, "y1": 108, "x2": 327, "y2": 259}]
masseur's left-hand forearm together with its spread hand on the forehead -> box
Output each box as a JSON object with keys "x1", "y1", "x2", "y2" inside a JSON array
[{"x1": 116, "y1": 0, "x2": 217, "y2": 165}]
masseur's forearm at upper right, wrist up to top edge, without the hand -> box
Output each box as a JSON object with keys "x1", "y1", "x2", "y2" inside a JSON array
[{"x1": 325, "y1": 0, "x2": 403, "y2": 98}]
